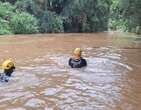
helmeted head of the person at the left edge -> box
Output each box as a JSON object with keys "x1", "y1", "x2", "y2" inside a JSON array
[{"x1": 2, "y1": 59, "x2": 15, "y2": 76}]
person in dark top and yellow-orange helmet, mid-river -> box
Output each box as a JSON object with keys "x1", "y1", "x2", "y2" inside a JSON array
[{"x1": 69, "y1": 48, "x2": 87, "y2": 68}]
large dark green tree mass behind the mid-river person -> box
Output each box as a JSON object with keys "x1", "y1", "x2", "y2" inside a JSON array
[{"x1": 61, "y1": 0, "x2": 110, "y2": 32}]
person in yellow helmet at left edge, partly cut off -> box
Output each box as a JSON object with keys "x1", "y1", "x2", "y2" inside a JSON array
[{"x1": 0, "y1": 59, "x2": 15, "y2": 82}]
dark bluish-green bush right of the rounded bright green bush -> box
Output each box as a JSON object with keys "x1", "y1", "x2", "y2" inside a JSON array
[{"x1": 41, "y1": 11, "x2": 64, "y2": 32}]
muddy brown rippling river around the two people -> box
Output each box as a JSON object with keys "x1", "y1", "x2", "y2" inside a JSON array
[{"x1": 0, "y1": 32, "x2": 141, "y2": 110}]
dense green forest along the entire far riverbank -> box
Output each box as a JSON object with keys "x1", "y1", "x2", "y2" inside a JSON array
[{"x1": 0, "y1": 0, "x2": 141, "y2": 34}]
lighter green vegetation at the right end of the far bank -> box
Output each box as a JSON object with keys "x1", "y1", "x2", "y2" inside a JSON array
[{"x1": 109, "y1": 0, "x2": 141, "y2": 34}]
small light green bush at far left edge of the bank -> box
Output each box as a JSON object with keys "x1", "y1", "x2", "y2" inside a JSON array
[{"x1": 0, "y1": 18, "x2": 12, "y2": 35}]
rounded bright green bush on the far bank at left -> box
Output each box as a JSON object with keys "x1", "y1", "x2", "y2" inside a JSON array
[{"x1": 10, "y1": 12, "x2": 38, "y2": 34}]
